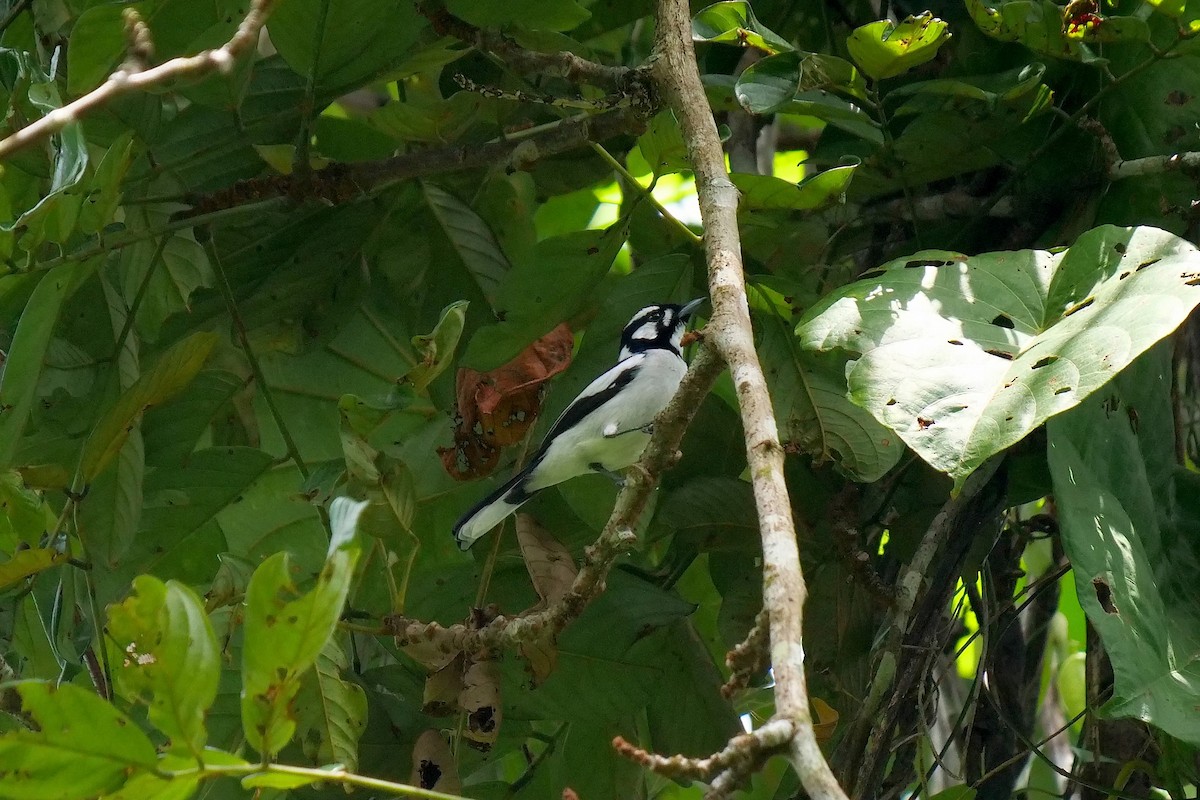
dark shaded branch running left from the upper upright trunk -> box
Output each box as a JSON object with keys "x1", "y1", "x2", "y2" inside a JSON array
[{"x1": 187, "y1": 108, "x2": 646, "y2": 216}]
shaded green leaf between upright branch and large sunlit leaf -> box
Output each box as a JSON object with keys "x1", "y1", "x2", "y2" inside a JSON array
[{"x1": 755, "y1": 314, "x2": 904, "y2": 482}]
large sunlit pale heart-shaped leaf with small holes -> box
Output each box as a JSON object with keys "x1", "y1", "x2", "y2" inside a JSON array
[{"x1": 797, "y1": 225, "x2": 1200, "y2": 487}]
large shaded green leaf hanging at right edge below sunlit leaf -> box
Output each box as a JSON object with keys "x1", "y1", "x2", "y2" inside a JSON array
[{"x1": 1046, "y1": 345, "x2": 1200, "y2": 745}]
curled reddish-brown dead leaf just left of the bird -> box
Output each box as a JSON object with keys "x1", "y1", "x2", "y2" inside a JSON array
[{"x1": 438, "y1": 323, "x2": 575, "y2": 481}]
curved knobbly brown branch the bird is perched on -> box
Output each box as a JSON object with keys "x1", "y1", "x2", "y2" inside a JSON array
[{"x1": 384, "y1": 344, "x2": 724, "y2": 654}]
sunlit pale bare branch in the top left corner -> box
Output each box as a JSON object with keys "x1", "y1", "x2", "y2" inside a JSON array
[{"x1": 0, "y1": 0, "x2": 275, "y2": 158}]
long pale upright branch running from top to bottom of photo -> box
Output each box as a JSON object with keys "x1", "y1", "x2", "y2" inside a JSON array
[{"x1": 653, "y1": 0, "x2": 846, "y2": 800}]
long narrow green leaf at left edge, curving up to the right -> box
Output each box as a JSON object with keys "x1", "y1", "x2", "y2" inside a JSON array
[{"x1": 0, "y1": 260, "x2": 97, "y2": 468}]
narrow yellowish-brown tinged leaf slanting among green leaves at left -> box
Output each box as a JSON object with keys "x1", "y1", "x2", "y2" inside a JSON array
[{"x1": 79, "y1": 332, "x2": 217, "y2": 483}]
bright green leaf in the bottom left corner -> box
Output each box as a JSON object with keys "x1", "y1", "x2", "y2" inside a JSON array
[{"x1": 0, "y1": 680, "x2": 157, "y2": 800}]
